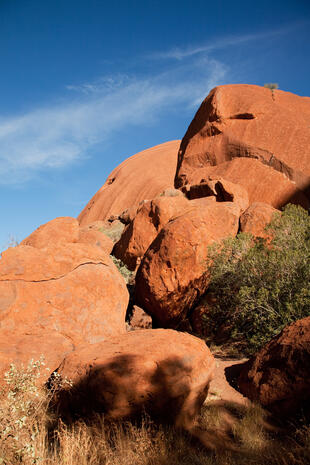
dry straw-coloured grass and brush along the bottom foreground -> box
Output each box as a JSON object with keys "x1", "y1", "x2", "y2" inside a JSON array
[{"x1": 0, "y1": 362, "x2": 310, "y2": 465}]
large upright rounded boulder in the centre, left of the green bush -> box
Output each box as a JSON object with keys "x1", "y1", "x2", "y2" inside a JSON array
[{"x1": 136, "y1": 199, "x2": 240, "y2": 327}]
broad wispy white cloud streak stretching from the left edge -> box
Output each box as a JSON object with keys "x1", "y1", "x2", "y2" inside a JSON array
[{"x1": 0, "y1": 58, "x2": 227, "y2": 184}]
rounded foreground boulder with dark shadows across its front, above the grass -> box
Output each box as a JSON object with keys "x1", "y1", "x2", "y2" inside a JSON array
[{"x1": 51, "y1": 329, "x2": 215, "y2": 427}]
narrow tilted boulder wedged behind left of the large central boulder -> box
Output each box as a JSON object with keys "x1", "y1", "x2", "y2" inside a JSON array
[{"x1": 113, "y1": 191, "x2": 191, "y2": 270}]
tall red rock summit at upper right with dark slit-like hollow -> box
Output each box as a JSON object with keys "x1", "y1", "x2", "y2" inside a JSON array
[{"x1": 175, "y1": 85, "x2": 310, "y2": 208}]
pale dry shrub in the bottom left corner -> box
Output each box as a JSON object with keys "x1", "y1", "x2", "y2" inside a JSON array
[{"x1": 0, "y1": 356, "x2": 71, "y2": 465}]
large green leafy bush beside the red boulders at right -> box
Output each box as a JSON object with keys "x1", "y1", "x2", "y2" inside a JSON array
[{"x1": 205, "y1": 205, "x2": 310, "y2": 353}]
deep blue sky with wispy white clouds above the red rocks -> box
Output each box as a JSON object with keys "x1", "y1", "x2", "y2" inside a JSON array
[{"x1": 0, "y1": 0, "x2": 310, "y2": 250}]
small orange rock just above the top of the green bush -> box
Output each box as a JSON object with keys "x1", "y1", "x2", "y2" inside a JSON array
[{"x1": 240, "y1": 202, "x2": 281, "y2": 237}]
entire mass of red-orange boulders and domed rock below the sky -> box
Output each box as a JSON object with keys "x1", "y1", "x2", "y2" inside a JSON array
[{"x1": 0, "y1": 85, "x2": 310, "y2": 429}]
